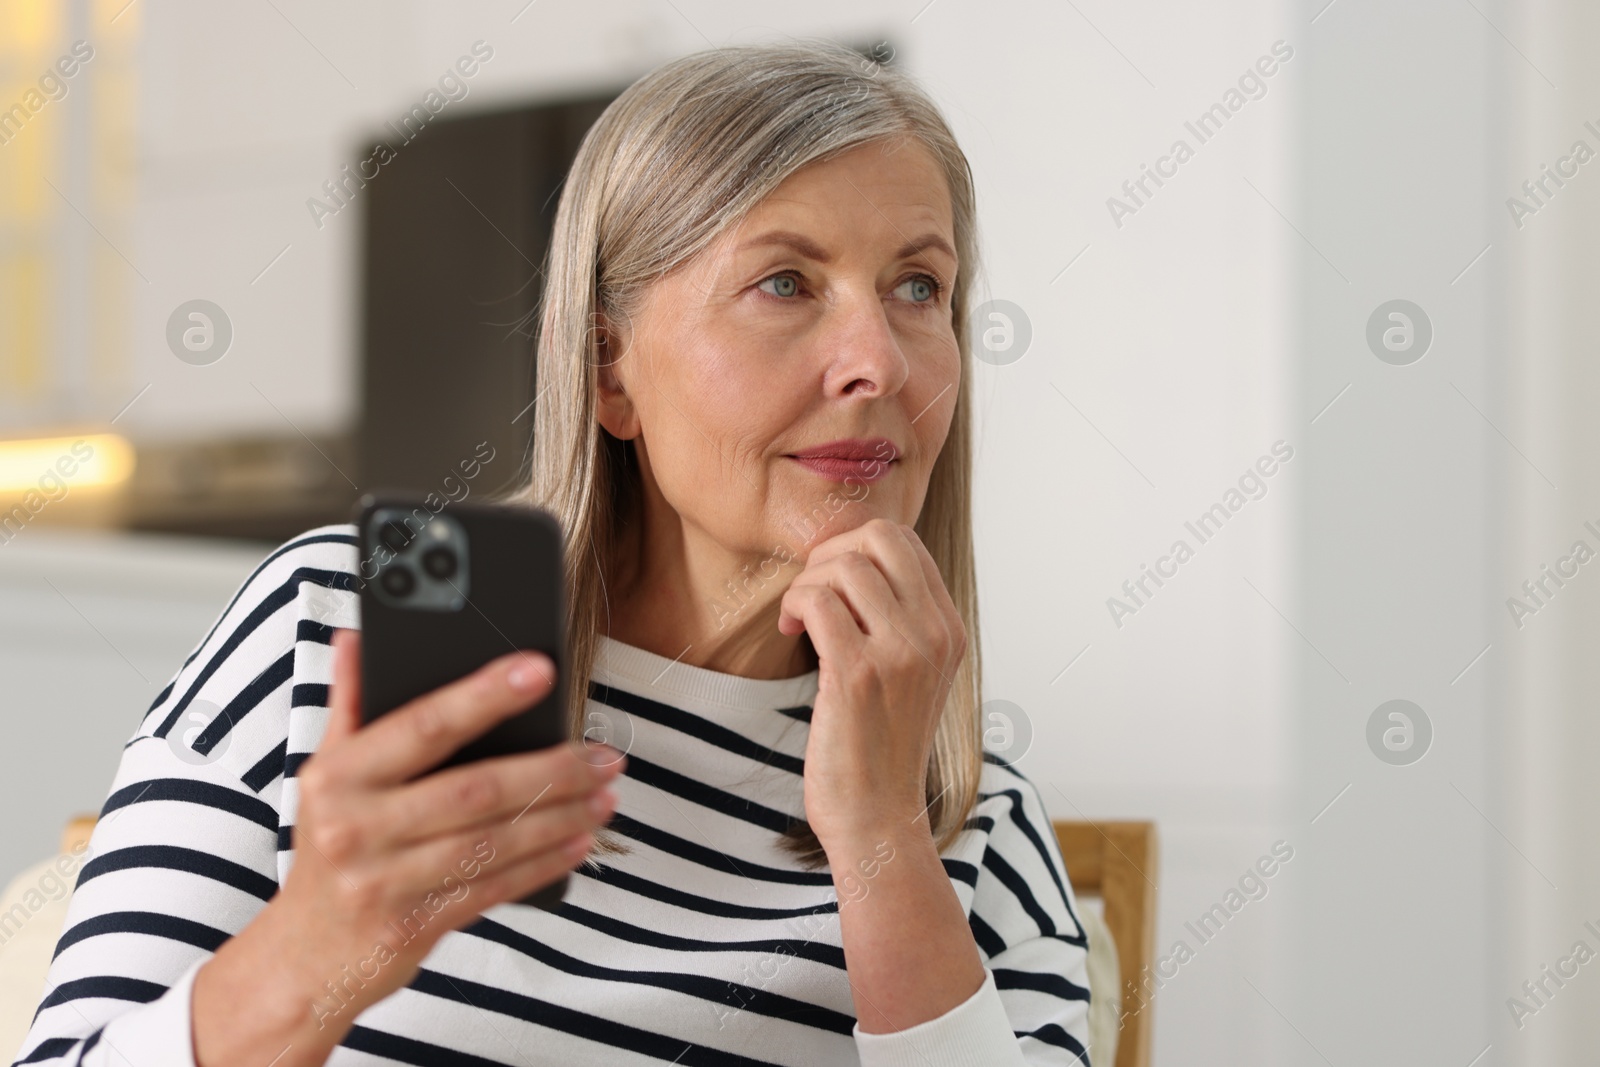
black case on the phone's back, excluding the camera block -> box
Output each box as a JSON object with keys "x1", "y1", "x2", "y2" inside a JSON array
[{"x1": 357, "y1": 494, "x2": 568, "y2": 910}]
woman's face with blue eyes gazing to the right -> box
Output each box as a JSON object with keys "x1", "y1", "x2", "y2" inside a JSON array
[{"x1": 598, "y1": 141, "x2": 962, "y2": 566}]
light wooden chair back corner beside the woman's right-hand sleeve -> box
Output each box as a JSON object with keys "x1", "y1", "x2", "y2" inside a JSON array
[{"x1": 1054, "y1": 819, "x2": 1158, "y2": 1067}]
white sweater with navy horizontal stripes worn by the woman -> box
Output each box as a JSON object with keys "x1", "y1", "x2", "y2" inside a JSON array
[{"x1": 18, "y1": 526, "x2": 1088, "y2": 1067}]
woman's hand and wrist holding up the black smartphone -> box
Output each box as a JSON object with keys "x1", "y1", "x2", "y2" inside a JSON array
[{"x1": 192, "y1": 630, "x2": 626, "y2": 1067}]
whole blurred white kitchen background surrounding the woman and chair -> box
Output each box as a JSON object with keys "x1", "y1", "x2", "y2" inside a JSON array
[{"x1": 0, "y1": 0, "x2": 1600, "y2": 1067}]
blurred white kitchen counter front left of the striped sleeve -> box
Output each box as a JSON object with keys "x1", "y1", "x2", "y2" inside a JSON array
[{"x1": 0, "y1": 526, "x2": 270, "y2": 885}]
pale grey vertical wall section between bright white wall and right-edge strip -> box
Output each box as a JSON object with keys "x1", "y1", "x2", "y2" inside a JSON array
[{"x1": 1256, "y1": 2, "x2": 1497, "y2": 1064}]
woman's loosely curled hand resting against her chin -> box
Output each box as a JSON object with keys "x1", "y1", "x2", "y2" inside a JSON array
[{"x1": 778, "y1": 518, "x2": 966, "y2": 849}]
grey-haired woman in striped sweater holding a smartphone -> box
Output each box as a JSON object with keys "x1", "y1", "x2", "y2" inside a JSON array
[{"x1": 19, "y1": 37, "x2": 1088, "y2": 1067}]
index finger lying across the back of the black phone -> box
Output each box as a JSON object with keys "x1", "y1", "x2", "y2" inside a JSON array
[{"x1": 341, "y1": 651, "x2": 563, "y2": 785}]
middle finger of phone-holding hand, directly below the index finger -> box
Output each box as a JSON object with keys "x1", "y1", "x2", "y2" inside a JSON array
[{"x1": 373, "y1": 744, "x2": 626, "y2": 845}]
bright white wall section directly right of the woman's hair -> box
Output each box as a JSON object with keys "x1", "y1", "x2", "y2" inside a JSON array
[{"x1": 947, "y1": 3, "x2": 1310, "y2": 1064}]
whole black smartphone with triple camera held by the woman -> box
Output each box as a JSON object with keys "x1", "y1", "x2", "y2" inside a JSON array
[{"x1": 357, "y1": 494, "x2": 568, "y2": 909}]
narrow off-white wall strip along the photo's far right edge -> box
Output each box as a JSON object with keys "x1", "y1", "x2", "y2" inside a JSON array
[{"x1": 1491, "y1": 0, "x2": 1600, "y2": 1064}]
